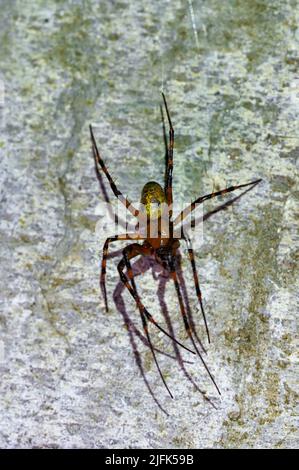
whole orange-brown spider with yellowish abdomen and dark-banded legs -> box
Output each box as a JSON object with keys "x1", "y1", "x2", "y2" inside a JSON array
[{"x1": 89, "y1": 92, "x2": 261, "y2": 398}]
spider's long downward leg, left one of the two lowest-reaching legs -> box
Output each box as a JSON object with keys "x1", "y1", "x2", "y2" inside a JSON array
[{"x1": 119, "y1": 243, "x2": 173, "y2": 398}]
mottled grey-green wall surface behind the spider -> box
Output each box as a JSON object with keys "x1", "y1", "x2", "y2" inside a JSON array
[{"x1": 0, "y1": 0, "x2": 299, "y2": 448}]
